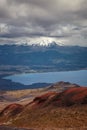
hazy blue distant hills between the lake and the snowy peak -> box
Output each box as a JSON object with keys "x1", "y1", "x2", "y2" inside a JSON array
[{"x1": 0, "y1": 42, "x2": 87, "y2": 71}]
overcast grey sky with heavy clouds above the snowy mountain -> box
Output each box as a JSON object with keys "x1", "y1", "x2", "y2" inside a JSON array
[{"x1": 0, "y1": 0, "x2": 87, "y2": 46}]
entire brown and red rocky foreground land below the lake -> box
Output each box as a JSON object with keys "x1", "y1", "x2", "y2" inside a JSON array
[{"x1": 0, "y1": 82, "x2": 87, "y2": 130}]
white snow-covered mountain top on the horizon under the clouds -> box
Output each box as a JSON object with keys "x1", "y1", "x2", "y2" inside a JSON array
[{"x1": 0, "y1": 37, "x2": 65, "y2": 46}]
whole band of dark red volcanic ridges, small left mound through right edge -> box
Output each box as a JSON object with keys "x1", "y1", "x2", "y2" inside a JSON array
[{"x1": 0, "y1": 87, "x2": 87, "y2": 117}]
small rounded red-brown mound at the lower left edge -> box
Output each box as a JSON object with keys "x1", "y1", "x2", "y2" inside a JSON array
[{"x1": 0, "y1": 103, "x2": 23, "y2": 116}]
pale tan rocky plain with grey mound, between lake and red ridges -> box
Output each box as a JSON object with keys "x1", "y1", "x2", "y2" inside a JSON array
[{"x1": 0, "y1": 81, "x2": 79, "y2": 110}]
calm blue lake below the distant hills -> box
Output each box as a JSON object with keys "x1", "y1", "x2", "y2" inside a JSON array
[{"x1": 4, "y1": 70, "x2": 87, "y2": 86}]
